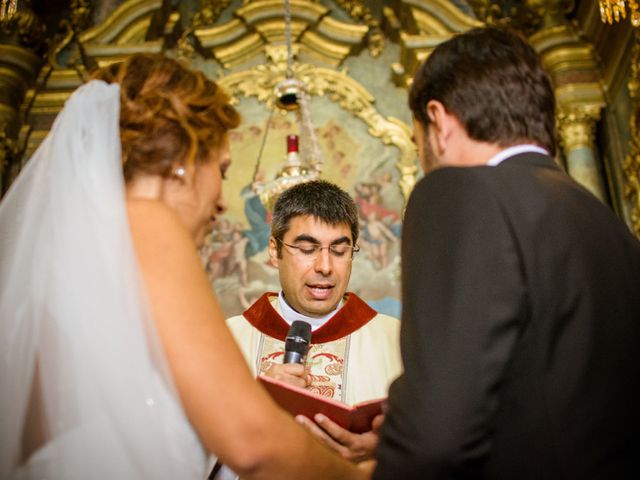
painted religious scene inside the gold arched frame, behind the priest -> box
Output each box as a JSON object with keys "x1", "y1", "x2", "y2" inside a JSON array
[{"x1": 202, "y1": 97, "x2": 404, "y2": 316}]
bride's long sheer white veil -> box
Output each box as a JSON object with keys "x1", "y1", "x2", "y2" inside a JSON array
[{"x1": 0, "y1": 81, "x2": 205, "y2": 480}]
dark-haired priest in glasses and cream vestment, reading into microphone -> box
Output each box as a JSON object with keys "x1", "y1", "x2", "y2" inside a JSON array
[{"x1": 218, "y1": 181, "x2": 401, "y2": 480}]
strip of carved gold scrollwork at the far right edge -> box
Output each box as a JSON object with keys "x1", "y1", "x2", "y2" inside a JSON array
[{"x1": 622, "y1": 32, "x2": 640, "y2": 238}]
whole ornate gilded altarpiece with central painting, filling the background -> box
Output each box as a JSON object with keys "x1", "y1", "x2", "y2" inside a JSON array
[{"x1": 6, "y1": 0, "x2": 640, "y2": 322}]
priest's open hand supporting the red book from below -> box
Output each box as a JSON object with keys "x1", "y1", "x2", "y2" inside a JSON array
[{"x1": 296, "y1": 413, "x2": 384, "y2": 463}]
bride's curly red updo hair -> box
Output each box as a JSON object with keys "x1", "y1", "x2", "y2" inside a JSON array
[{"x1": 92, "y1": 54, "x2": 240, "y2": 180}]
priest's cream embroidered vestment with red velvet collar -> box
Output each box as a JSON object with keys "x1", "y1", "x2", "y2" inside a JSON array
[{"x1": 215, "y1": 293, "x2": 402, "y2": 480}]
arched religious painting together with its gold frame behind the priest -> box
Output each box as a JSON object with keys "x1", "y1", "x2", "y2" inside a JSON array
[{"x1": 208, "y1": 48, "x2": 417, "y2": 316}]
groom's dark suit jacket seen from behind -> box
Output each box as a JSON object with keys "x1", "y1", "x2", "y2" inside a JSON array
[{"x1": 374, "y1": 153, "x2": 640, "y2": 480}]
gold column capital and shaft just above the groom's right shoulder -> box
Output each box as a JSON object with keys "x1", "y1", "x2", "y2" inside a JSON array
[{"x1": 558, "y1": 105, "x2": 606, "y2": 202}]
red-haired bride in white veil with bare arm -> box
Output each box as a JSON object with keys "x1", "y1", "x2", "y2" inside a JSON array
[{"x1": 0, "y1": 54, "x2": 363, "y2": 479}]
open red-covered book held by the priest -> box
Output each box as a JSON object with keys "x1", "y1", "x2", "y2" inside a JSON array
[{"x1": 258, "y1": 375, "x2": 386, "y2": 433}]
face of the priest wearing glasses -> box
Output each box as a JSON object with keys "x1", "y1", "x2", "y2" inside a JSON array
[{"x1": 269, "y1": 215, "x2": 353, "y2": 317}]
